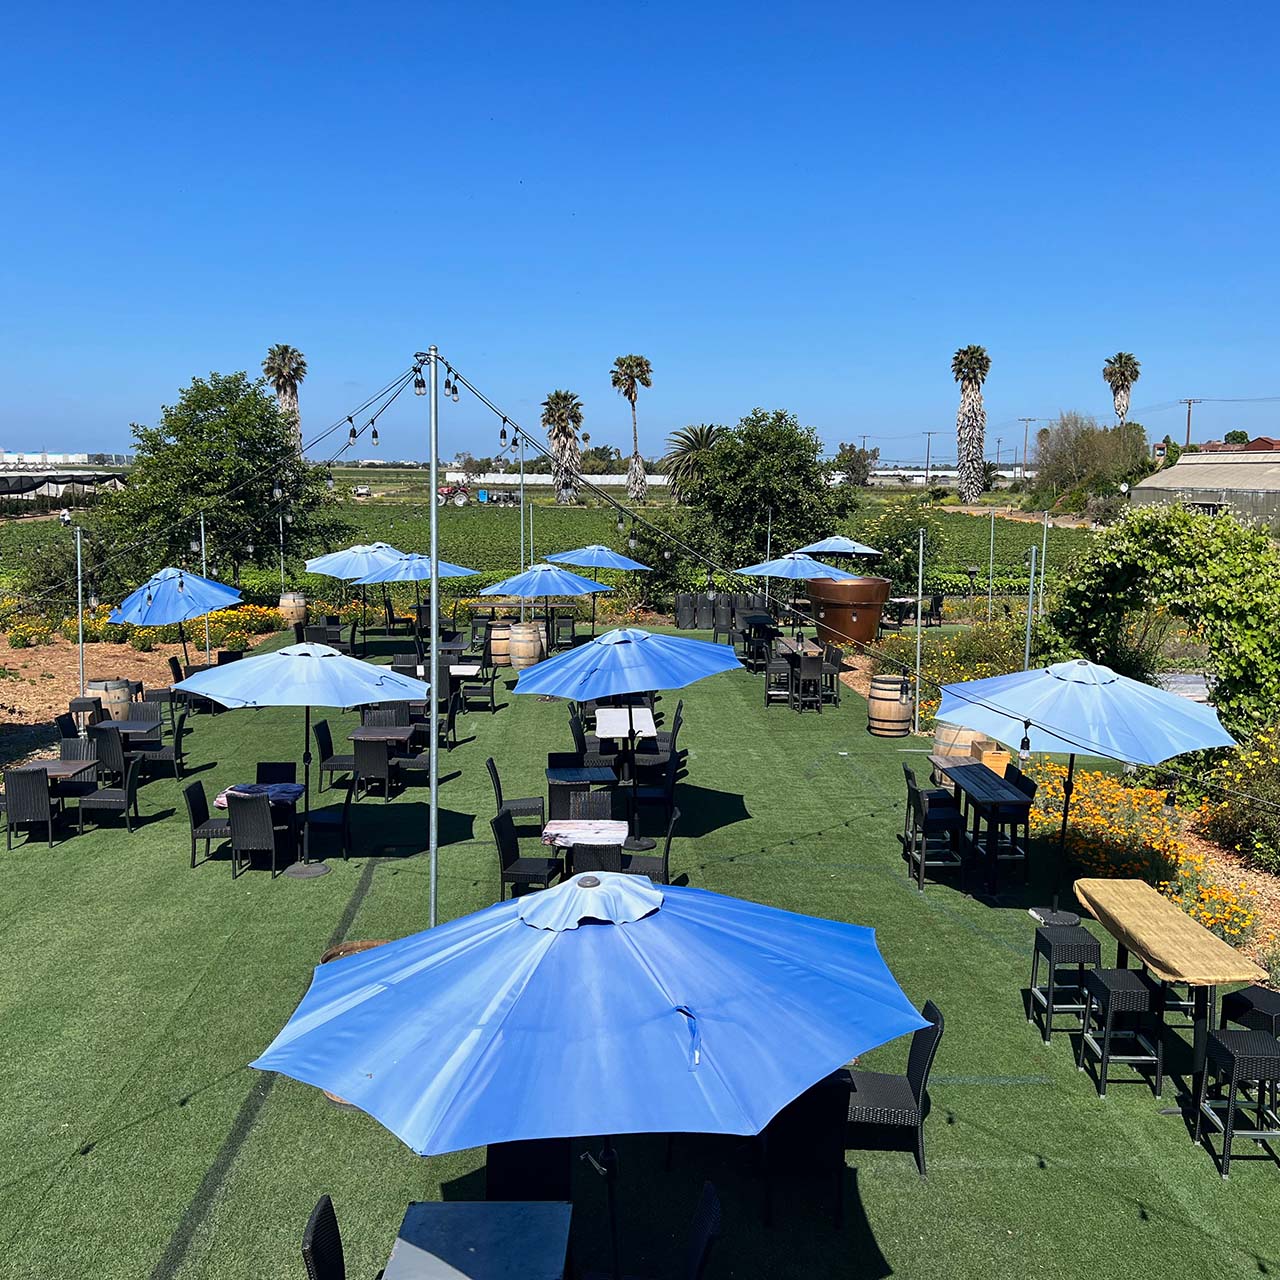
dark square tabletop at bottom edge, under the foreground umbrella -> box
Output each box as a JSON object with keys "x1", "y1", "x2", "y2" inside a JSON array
[{"x1": 383, "y1": 1201, "x2": 573, "y2": 1280}]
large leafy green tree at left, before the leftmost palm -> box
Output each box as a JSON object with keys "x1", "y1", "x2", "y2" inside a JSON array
[{"x1": 93, "y1": 372, "x2": 348, "y2": 581}]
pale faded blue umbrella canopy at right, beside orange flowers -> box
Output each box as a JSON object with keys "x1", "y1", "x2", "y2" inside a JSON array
[{"x1": 937, "y1": 659, "x2": 1235, "y2": 764}]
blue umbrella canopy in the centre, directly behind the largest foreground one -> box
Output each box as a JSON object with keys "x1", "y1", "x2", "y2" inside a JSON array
[{"x1": 516, "y1": 627, "x2": 741, "y2": 703}]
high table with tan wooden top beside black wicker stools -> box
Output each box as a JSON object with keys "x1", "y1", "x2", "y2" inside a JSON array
[{"x1": 1075, "y1": 879, "x2": 1267, "y2": 1074}]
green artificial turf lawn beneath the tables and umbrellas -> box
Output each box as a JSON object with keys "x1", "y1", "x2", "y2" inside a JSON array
[{"x1": 0, "y1": 632, "x2": 1280, "y2": 1280}]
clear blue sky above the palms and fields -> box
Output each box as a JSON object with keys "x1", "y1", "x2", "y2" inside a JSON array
[{"x1": 0, "y1": 0, "x2": 1280, "y2": 457}]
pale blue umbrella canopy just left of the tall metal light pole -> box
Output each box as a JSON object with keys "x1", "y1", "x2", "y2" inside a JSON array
[{"x1": 174, "y1": 644, "x2": 431, "y2": 707}]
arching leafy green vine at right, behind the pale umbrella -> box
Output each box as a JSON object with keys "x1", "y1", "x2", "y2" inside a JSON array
[{"x1": 1052, "y1": 506, "x2": 1280, "y2": 733}]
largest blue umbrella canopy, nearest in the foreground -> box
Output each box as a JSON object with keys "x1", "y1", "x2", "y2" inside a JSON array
[{"x1": 252, "y1": 872, "x2": 924, "y2": 1155}]
